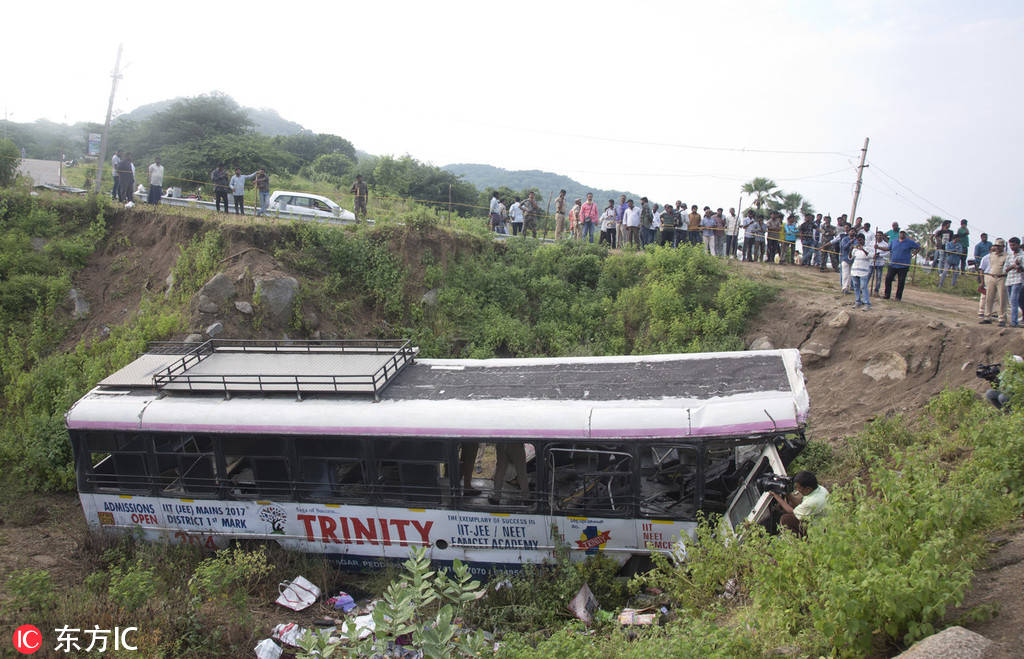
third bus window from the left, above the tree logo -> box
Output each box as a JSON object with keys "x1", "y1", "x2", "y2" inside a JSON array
[{"x1": 221, "y1": 437, "x2": 292, "y2": 498}]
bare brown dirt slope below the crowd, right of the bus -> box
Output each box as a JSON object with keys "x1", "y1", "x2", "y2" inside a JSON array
[{"x1": 736, "y1": 263, "x2": 1024, "y2": 440}]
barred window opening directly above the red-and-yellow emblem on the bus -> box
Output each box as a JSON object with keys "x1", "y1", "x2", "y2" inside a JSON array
[{"x1": 546, "y1": 443, "x2": 636, "y2": 517}]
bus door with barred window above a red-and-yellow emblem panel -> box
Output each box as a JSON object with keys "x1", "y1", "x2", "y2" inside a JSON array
[{"x1": 545, "y1": 442, "x2": 637, "y2": 563}]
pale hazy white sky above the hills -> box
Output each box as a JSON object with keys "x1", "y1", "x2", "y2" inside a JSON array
[{"x1": 0, "y1": 0, "x2": 1024, "y2": 241}]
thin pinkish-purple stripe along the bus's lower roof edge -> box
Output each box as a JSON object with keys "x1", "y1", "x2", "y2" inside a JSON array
[{"x1": 68, "y1": 420, "x2": 797, "y2": 439}]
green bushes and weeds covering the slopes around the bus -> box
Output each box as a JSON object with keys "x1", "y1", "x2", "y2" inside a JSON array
[{"x1": 0, "y1": 190, "x2": 1024, "y2": 657}]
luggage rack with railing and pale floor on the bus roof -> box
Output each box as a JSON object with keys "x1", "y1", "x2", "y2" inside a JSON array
[{"x1": 115, "y1": 339, "x2": 419, "y2": 400}]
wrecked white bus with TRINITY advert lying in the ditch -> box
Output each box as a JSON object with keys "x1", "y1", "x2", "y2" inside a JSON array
[{"x1": 67, "y1": 340, "x2": 809, "y2": 573}]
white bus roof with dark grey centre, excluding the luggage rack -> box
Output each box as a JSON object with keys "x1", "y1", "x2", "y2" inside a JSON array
[{"x1": 67, "y1": 350, "x2": 809, "y2": 439}]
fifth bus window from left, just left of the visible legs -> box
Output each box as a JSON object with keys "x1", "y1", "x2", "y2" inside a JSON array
[{"x1": 373, "y1": 439, "x2": 449, "y2": 506}]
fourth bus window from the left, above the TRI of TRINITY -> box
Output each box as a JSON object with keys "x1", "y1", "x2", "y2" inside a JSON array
[{"x1": 295, "y1": 437, "x2": 370, "y2": 503}]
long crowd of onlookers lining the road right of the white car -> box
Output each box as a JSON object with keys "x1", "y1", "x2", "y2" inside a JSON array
[{"x1": 489, "y1": 190, "x2": 1024, "y2": 327}]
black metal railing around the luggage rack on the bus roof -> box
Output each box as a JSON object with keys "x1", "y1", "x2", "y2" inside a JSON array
[{"x1": 146, "y1": 339, "x2": 418, "y2": 400}]
